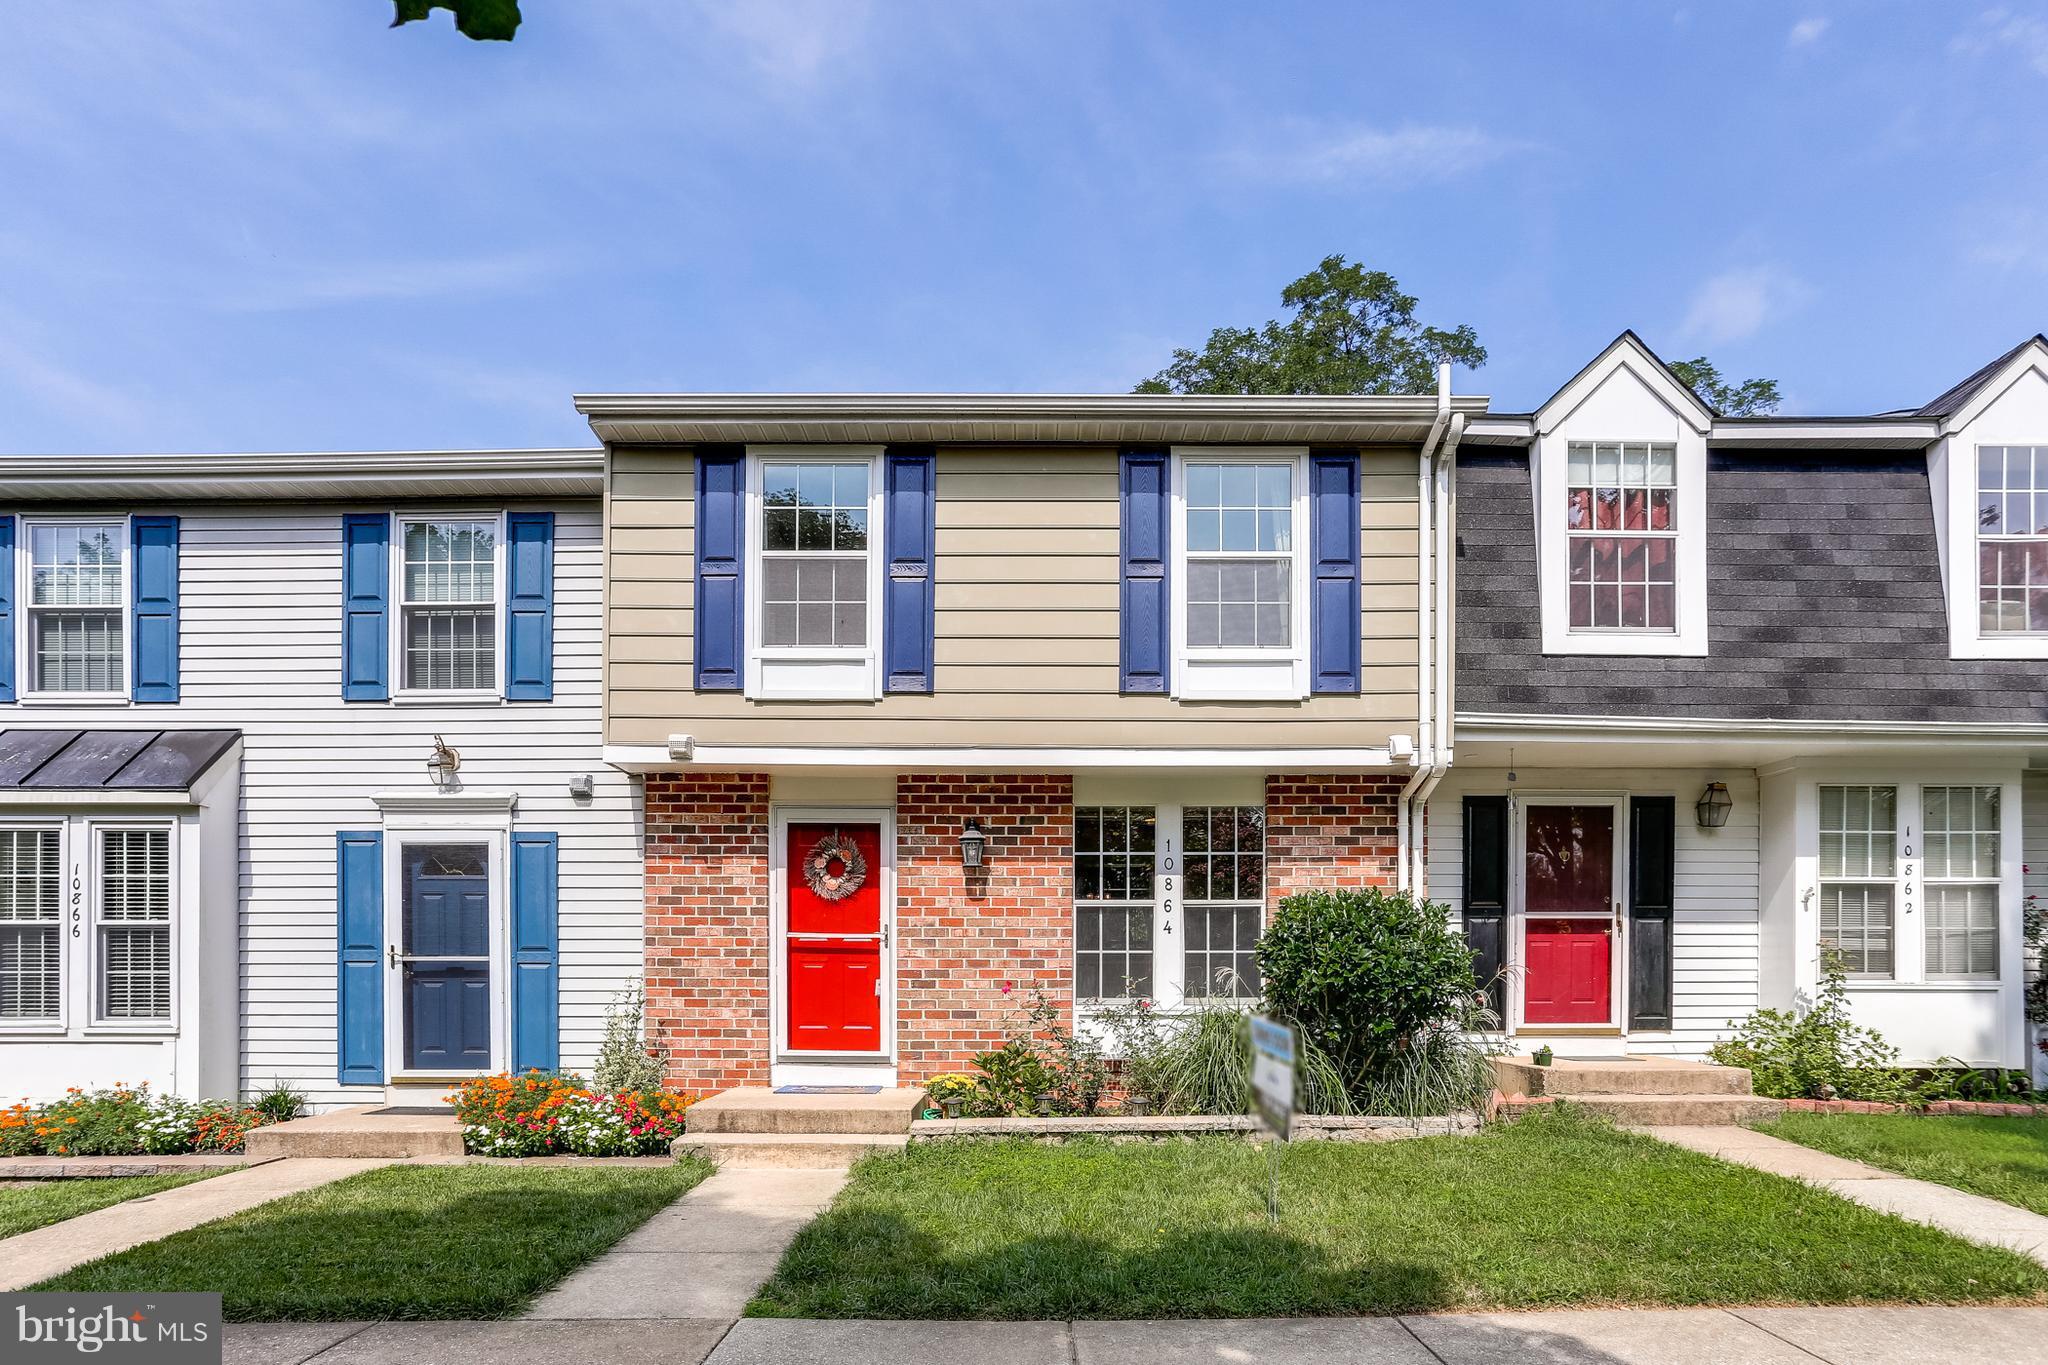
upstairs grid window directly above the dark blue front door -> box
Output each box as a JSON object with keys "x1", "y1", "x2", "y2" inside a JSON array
[{"x1": 399, "y1": 518, "x2": 498, "y2": 692}]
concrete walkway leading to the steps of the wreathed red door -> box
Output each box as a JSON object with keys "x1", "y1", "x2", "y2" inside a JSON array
[{"x1": 526, "y1": 1166, "x2": 846, "y2": 1326}]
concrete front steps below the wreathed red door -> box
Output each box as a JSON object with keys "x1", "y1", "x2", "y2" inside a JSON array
[{"x1": 674, "y1": 1087, "x2": 924, "y2": 1169}]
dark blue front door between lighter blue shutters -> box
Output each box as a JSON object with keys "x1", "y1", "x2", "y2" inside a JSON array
[{"x1": 399, "y1": 843, "x2": 492, "y2": 1070}]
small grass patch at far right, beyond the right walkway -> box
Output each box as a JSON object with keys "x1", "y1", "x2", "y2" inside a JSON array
[{"x1": 1757, "y1": 1113, "x2": 2048, "y2": 1214}]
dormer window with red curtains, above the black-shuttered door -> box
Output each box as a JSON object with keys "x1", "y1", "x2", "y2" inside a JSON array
[{"x1": 1565, "y1": 440, "x2": 1677, "y2": 630}]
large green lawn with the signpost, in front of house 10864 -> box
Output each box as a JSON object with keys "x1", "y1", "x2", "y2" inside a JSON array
[{"x1": 748, "y1": 1115, "x2": 2048, "y2": 1318}]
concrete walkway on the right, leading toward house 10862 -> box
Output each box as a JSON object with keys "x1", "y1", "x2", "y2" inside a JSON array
[{"x1": 1642, "y1": 1128, "x2": 2048, "y2": 1265}]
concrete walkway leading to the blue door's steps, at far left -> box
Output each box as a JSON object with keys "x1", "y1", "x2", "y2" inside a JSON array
[{"x1": 0, "y1": 1160, "x2": 389, "y2": 1291}]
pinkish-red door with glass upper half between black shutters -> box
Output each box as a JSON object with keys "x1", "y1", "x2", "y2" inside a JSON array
[{"x1": 1522, "y1": 806, "x2": 1614, "y2": 1023}]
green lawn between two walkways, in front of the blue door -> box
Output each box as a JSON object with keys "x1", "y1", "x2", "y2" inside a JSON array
[{"x1": 35, "y1": 1158, "x2": 711, "y2": 1322}]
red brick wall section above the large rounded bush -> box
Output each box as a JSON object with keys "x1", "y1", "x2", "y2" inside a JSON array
[{"x1": 1266, "y1": 774, "x2": 1407, "y2": 917}]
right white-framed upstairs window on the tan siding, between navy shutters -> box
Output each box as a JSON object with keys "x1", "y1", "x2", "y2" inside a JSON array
[{"x1": 1174, "y1": 450, "x2": 1309, "y2": 700}]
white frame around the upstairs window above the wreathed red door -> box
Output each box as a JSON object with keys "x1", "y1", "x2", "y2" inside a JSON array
[{"x1": 745, "y1": 444, "x2": 887, "y2": 702}]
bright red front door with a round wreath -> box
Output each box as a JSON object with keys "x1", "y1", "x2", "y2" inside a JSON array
[{"x1": 786, "y1": 825, "x2": 883, "y2": 1052}]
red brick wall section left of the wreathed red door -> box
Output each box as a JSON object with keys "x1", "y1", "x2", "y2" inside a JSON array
[{"x1": 645, "y1": 774, "x2": 772, "y2": 1093}]
